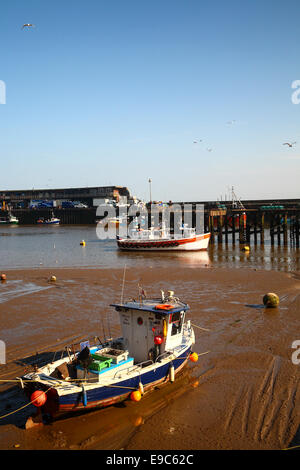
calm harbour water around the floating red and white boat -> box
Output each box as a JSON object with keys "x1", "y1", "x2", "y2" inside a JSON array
[{"x1": 0, "y1": 226, "x2": 300, "y2": 271}]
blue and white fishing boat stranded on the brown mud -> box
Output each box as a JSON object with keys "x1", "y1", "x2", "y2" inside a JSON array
[{"x1": 20, "y1": 291, "x2": 198, "y2": 419}]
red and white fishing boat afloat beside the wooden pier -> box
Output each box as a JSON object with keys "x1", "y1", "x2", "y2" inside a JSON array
[{"x1": 117, "y1": 226, "x2": 210, "y2": 251}]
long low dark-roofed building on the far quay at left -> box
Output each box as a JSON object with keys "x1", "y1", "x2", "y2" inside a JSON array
[{"x1": 0, "y1": 186, "x2": 131, "y2": 208}]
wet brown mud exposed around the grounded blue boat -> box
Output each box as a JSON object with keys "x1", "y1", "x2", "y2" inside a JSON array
[{"x1": 0, "y1": 265, "x2": 300, "y2": 450}]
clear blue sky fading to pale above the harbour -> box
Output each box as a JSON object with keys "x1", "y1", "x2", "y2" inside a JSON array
[{"x1": 0, "y1": 0, "x2": 300, "y2": 201}]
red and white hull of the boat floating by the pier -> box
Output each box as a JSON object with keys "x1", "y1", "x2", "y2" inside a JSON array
[{"x1": 117, "y1": 233, "x2": 210, "y2": 251}]
